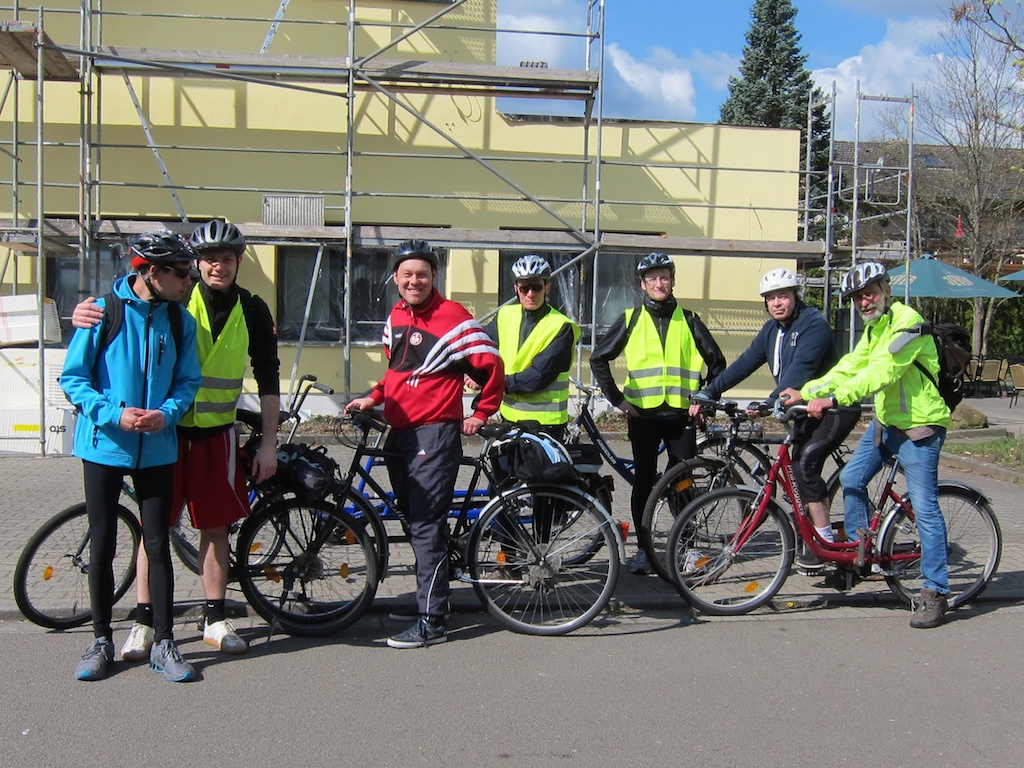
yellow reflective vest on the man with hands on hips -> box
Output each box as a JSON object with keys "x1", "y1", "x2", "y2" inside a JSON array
[{"x1": 623, "y1": 306, "x2": 703, "y2": 410}]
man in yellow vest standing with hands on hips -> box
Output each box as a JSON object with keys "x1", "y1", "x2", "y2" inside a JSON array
[{"x1": 590, "y1": 253, "x2": 725, "y2": 574}]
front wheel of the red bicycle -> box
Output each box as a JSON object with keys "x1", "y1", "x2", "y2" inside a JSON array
[{"x1": 669, "y1": 488, "x2": 795, "y2": 615}]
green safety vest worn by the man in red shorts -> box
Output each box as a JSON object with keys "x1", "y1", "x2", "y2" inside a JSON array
[{"x1": 181, "y1": 289, "x2": 249, "y2": 427}]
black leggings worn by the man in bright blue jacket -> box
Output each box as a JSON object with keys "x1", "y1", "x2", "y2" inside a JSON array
[{"x1": 82, "y1": 461, "x2": 174, "y2": 642}]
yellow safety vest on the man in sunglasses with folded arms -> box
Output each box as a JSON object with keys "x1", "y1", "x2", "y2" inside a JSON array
[{"x1": 498, "y1": 304, "x2": 580, "y2": 425}]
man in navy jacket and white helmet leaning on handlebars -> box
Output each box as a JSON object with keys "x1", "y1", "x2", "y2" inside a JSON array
[{"x1": 690, "y1": 268, "x2": 860, "y2": 571}]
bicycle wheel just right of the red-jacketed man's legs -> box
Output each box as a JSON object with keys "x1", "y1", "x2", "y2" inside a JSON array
[{"x1": 466, "y1": 485, "x2": 618, "y2": 635}]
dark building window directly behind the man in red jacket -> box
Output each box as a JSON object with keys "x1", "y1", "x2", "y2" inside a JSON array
[{"x1": 278, "y1": 246, "x2": 447, "y2": 344}]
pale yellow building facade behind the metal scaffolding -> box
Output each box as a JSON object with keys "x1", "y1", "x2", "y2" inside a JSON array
[{"x1": 0, "y1": 0, "x2": 814, "y2": 421}]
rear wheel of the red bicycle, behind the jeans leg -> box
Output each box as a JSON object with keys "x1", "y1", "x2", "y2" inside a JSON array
[{"x1": 881, "y1": 483, "x2": 1002, "y2": 608}]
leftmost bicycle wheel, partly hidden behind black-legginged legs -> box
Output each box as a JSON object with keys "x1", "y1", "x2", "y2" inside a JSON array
[{"x1": 14, "y1": 502, "x2": 142, "y2": 630}]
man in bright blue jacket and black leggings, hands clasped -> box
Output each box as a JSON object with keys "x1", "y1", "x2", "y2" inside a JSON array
[{"x1": 60, "y1": 230, "x2": 202, "y2": 682}]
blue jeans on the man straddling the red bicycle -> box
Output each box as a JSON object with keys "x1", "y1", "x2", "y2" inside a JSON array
[{"x1": 840, "y1": 420, "x2": 949, "y2": 595}]
